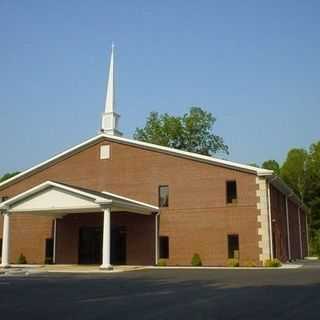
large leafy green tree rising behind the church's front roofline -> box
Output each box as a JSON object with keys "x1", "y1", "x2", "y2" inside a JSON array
[{"x1": 133, "y1": 107, "x2": 229, "y2": 155}]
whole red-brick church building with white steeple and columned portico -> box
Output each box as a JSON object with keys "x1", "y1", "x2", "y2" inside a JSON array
[{"x1": 0, "y1": 45, "x2": 308, "y2": 268}]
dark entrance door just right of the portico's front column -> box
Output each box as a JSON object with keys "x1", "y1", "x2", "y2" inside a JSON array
[{"x1": 110, "y1": 226, "x2": 127, "y2": 265}]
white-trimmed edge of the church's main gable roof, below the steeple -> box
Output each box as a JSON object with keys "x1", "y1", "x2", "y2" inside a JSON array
[{"x1": 0, "y1": 133, "x2": 273, "y2": 189}]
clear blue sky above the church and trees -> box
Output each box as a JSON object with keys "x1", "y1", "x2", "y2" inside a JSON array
[{"x1": 0, "y1": 0, "x2": 320, "y2": 175}]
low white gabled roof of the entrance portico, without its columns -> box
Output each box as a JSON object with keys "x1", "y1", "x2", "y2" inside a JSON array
[{"x1": 0, "y1": 181, "x2": 159, "y2": 216}]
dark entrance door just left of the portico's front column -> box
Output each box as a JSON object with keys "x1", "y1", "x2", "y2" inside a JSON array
[{"x1": 79, "y1": 227, "x2": 102, "y2": 264}]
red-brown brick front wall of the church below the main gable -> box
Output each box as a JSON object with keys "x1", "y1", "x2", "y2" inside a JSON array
[{"x1": 0, "y1": 138, "x2": 260, "y2": 265}]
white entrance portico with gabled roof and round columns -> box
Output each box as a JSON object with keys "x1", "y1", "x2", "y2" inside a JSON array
[{"x1": 0, "y1": 181, "x2": 159, "y2": 269}]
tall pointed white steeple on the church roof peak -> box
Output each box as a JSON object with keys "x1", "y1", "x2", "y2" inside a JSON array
[{"x1": 101, "y1": 43, "x2": 122, "y2": 136}]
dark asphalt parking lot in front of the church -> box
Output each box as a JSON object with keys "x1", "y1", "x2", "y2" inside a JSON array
[{"x1": 0, "y1": 262, "x2": 320, "y2": 320}]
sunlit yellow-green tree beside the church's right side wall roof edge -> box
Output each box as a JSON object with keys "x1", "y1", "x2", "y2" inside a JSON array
[{"x1": 280, "y1": 149, "x2": 308, "y2": 201}]
